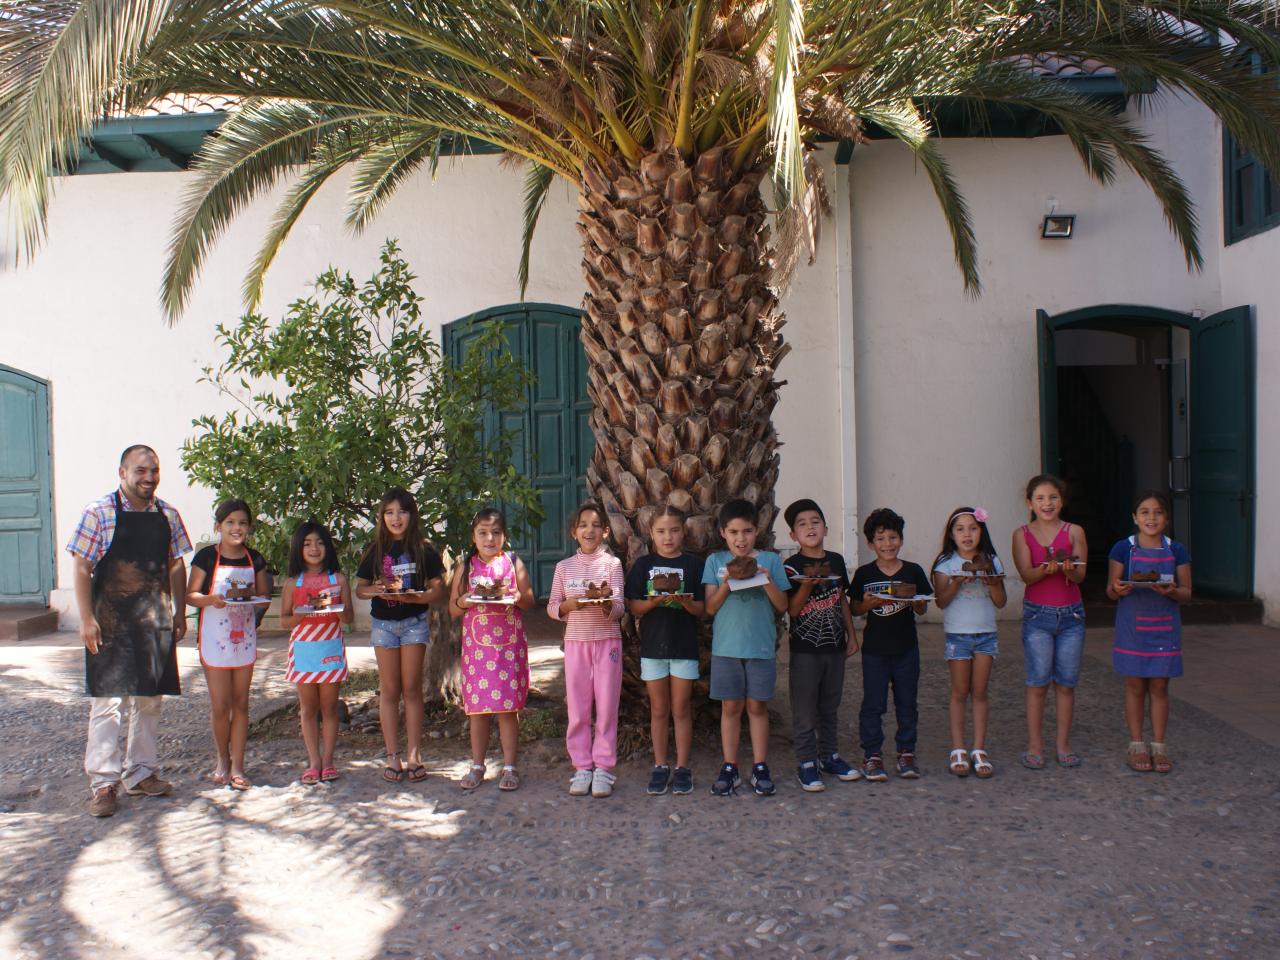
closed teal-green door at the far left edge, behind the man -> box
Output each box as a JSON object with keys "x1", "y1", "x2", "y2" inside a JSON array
[{"x1": 0, "y1": 366, "x2": 54, "y2": 605}]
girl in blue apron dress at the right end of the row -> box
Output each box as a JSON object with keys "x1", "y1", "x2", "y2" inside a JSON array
[{"x1": 1107, "y1": 490, "x2": 1192, "y2": 773}]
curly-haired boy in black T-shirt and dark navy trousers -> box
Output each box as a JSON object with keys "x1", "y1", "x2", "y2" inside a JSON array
[{"x1": 849, "y1": 507, "x2": 933, "y2": 782}]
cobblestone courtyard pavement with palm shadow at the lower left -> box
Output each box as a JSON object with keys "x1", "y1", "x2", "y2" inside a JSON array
[{"x1": 0, "y1": 627, "x2": 1280, "y2": 960}]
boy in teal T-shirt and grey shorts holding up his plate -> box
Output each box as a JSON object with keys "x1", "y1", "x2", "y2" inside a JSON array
[{"x1": 703, "y1": 500, "x2": 791, "y2": 796}]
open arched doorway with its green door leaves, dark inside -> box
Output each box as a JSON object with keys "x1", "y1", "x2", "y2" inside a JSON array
[{"x1": 1037, "y1": 303, "x2": 1256, "y2": 598}]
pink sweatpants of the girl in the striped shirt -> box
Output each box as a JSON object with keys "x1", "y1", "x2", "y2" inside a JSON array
[{"x1": 564, "y1": 637, "x2": 622, "y2": 771}]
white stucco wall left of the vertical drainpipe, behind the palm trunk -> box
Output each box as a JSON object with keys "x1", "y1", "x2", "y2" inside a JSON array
[{"x1": 0, "y1": 144, "x2": 840, "y2": 627}]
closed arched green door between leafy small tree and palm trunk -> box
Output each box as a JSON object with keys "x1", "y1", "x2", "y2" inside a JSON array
[{"x1": 444, "y1": 303, "x2": 595, "y2": 596}]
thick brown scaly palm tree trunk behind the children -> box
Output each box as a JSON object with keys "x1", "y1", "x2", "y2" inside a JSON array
[{"x1": 577, "y1": 148, "x2": 788, "y2": 564}]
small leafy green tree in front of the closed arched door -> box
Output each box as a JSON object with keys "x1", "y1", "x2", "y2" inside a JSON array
[{"x1": 182, "y1": 241, "x2": 541, "y2": 694}]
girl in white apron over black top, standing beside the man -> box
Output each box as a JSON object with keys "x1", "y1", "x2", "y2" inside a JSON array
[{"x1": 187, "y1": 499, "x2": 270, "y2": 790}]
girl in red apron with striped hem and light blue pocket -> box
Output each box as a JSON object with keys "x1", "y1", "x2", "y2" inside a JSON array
[{"x1": 280, "y1": 521, "x2": 355, "y2": 786}]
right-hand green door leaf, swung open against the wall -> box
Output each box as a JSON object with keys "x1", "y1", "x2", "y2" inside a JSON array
[{"x1": 1188, "y1": 307, "x2": 1254, "y2": 596}]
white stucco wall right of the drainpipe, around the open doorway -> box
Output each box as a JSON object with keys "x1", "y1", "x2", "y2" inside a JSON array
[{"x1": 852, "y1": 100, "x2": 1280, "y2": 617}]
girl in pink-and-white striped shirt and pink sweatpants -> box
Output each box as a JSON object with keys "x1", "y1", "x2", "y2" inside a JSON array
[{"x1": 547, "y1": 500, "x2": 623, "y2": 796}]
